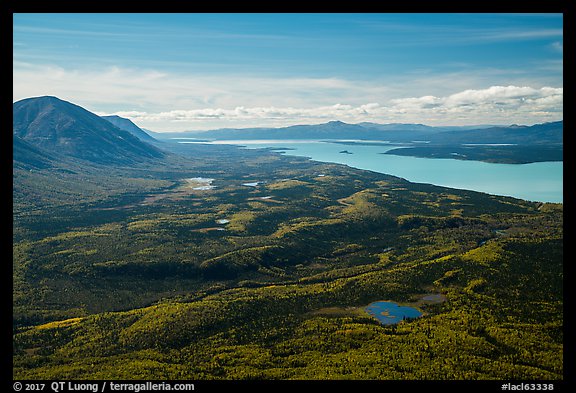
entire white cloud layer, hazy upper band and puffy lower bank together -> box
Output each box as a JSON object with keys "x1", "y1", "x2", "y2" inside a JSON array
[{"x1": 13, "y1": 61, "x2": 563, "y2": 131}]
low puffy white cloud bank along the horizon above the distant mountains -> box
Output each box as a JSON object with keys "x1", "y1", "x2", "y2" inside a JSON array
[{"x1": 108, "y1": 86, "x2": 563, "y2": 130}]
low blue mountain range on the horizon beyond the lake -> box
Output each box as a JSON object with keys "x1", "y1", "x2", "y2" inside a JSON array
[{"x1": 153, "y1": 121, "x2": 563, "y2": 145}]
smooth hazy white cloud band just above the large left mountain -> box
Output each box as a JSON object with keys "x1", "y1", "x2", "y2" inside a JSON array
[{"x1": 13, "y1": 62, "x2": 374, "y2": 110}]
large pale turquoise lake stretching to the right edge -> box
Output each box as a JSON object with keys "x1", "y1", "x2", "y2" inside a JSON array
[{"x1": 180, "y1": 140, "x2": 563, "y2": 203}]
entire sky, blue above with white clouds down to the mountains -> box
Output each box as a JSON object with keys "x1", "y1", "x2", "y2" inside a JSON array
[{"x1": 13, "y1": 13, "x2": 563, "y2": 131}]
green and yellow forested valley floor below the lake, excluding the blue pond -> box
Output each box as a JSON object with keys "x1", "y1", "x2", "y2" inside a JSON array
[{"x1": 13, "y1": 139, "x2": 563, "y2": 380}]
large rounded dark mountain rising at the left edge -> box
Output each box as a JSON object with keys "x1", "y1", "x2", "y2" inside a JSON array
[{"x1": 13, "y1": 96, "x2": 166, "y2": 167}]
